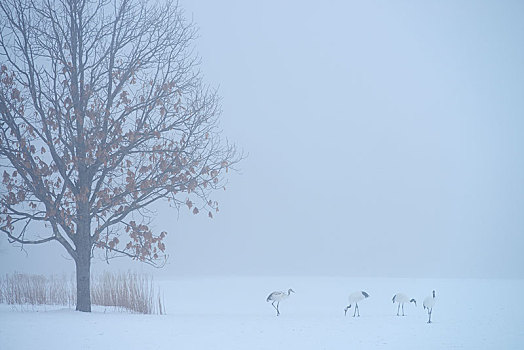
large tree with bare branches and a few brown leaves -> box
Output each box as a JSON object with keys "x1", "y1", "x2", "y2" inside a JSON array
[{"x1": 0, "y1": 0, "x2": 241, "y2": 311}]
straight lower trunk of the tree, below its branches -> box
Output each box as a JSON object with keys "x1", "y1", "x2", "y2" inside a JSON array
[{"x1": 75, "y1": 242, "x2": 91, "y2": 312}]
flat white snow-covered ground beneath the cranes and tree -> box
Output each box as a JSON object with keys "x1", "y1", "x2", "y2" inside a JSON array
[{"x1": 0, "y1": 277, "x2": 524, "y2": 350}]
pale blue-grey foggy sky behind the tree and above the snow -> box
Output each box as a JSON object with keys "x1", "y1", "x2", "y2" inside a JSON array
[{"x1": 0, "y1": 0, "x2": 524, "y2": 278}]
